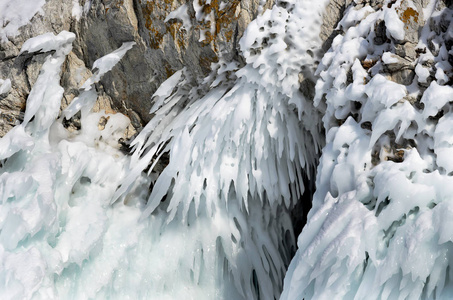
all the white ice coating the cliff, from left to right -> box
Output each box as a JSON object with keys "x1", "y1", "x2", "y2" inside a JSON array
[{"x1": 0, "y1": 0, "x2": 453, "y2": 300}]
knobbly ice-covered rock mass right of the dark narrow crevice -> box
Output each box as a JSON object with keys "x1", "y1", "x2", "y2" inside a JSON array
[{"x1": 282, "y1": 1, "x2": 453, "y2": 299}]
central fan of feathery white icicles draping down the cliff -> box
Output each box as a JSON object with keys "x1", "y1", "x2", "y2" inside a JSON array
[{"x1": 111, "y1": 1, "x2": 326, "y2": 299}]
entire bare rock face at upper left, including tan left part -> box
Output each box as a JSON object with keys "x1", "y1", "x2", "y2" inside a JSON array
[{"x1": 0, "y1": 0, "x2": 272, "y2": 136}]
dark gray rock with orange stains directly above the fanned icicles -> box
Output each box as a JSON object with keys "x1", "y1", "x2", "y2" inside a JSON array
[{"x1": 75, "y1": 0, "x2": 271, "y2": 124}]
